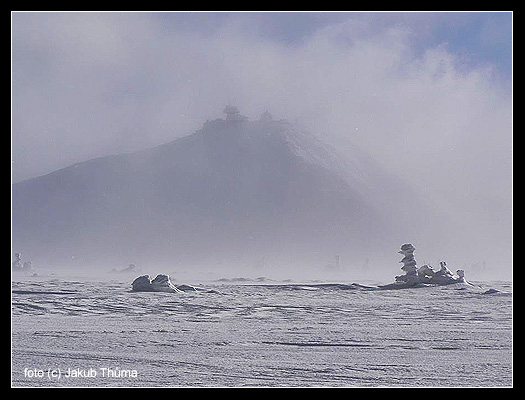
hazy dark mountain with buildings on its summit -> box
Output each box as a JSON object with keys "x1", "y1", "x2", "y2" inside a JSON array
[{"x1": 12, "y1": 107, "x2": 438, "y2": 265}]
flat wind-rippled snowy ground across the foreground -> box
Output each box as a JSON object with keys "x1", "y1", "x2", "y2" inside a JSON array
[{"x1": 12, "y1": 277, "x2": 513, "y2": 387}]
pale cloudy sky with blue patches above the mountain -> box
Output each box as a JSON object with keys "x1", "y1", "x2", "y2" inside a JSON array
[{"x1": 12, "y1": 12, "x2": 512, "y2": 272}]
